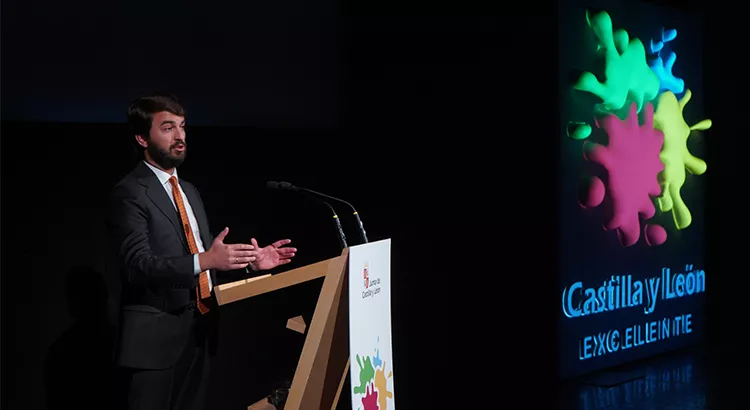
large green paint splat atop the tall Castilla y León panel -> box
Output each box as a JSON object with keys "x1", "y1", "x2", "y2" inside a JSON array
[{"x1": 574, "y1": 11, "x2": 659, "y2": 112}]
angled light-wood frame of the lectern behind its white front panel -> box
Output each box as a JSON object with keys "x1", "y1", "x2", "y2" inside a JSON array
[{"x1": 214, "y1": 248, "x2": 349, "y2": 410}]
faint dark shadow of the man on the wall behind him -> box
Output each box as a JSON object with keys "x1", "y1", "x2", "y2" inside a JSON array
[{"x1": 44, "y1": 266, "x2": 114, "y2": 410}]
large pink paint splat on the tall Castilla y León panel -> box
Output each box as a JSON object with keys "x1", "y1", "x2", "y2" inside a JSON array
[{"x1": 584, "y1": 103, "x2": 666, "y2": 246}]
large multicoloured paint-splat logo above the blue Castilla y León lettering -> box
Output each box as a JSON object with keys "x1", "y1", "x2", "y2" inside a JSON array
[{"x1": 567, "y1": 11, "x2": 711, "y2": 247}]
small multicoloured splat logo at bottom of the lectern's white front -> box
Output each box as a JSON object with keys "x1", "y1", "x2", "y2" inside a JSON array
[{"x1": 352, "y1": 338, "x2": 393, "y2": 410}]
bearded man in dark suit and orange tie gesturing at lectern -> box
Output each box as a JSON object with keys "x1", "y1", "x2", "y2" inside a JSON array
[{"x1": 107, "y1": 94, "x2": 296, "y2": 410}]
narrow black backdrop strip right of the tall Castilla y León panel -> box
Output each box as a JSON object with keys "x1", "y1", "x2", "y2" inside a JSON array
[{"x1": 704, "y1": 1, "x2": 750, "y2": 408}]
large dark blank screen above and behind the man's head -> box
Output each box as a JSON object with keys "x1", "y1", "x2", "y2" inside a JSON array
[{"x1": 3, "y1": 0, "x2": 341, "y2": 128}]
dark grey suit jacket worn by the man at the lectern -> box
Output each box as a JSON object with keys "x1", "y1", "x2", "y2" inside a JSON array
[{"x1": 106, "y1": 161, "x2": 217, "y2": 369}]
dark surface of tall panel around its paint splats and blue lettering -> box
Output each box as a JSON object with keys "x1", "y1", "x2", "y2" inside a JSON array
[{"x1": 557, "y1": 0, "x2": 721, "y2": 378}]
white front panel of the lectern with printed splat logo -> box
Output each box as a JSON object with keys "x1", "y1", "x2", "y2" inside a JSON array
[{"x1": 349, "y1": 239, "x2": 396, "y2": 410}]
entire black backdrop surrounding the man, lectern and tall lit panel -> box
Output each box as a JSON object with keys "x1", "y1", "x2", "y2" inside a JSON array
[{"x1": 0, "y1": 0, "x2": 748, "y2": 409}]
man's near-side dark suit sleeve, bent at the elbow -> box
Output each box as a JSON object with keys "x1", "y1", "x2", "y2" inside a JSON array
[{"x1": 107, "y1": 185, "x2": 195, "y2": 287}]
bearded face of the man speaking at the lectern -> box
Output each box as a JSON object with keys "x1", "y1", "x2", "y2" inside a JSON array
[{"x1": 139, "y1": 112, "x2": 187, "y2": 170}]
